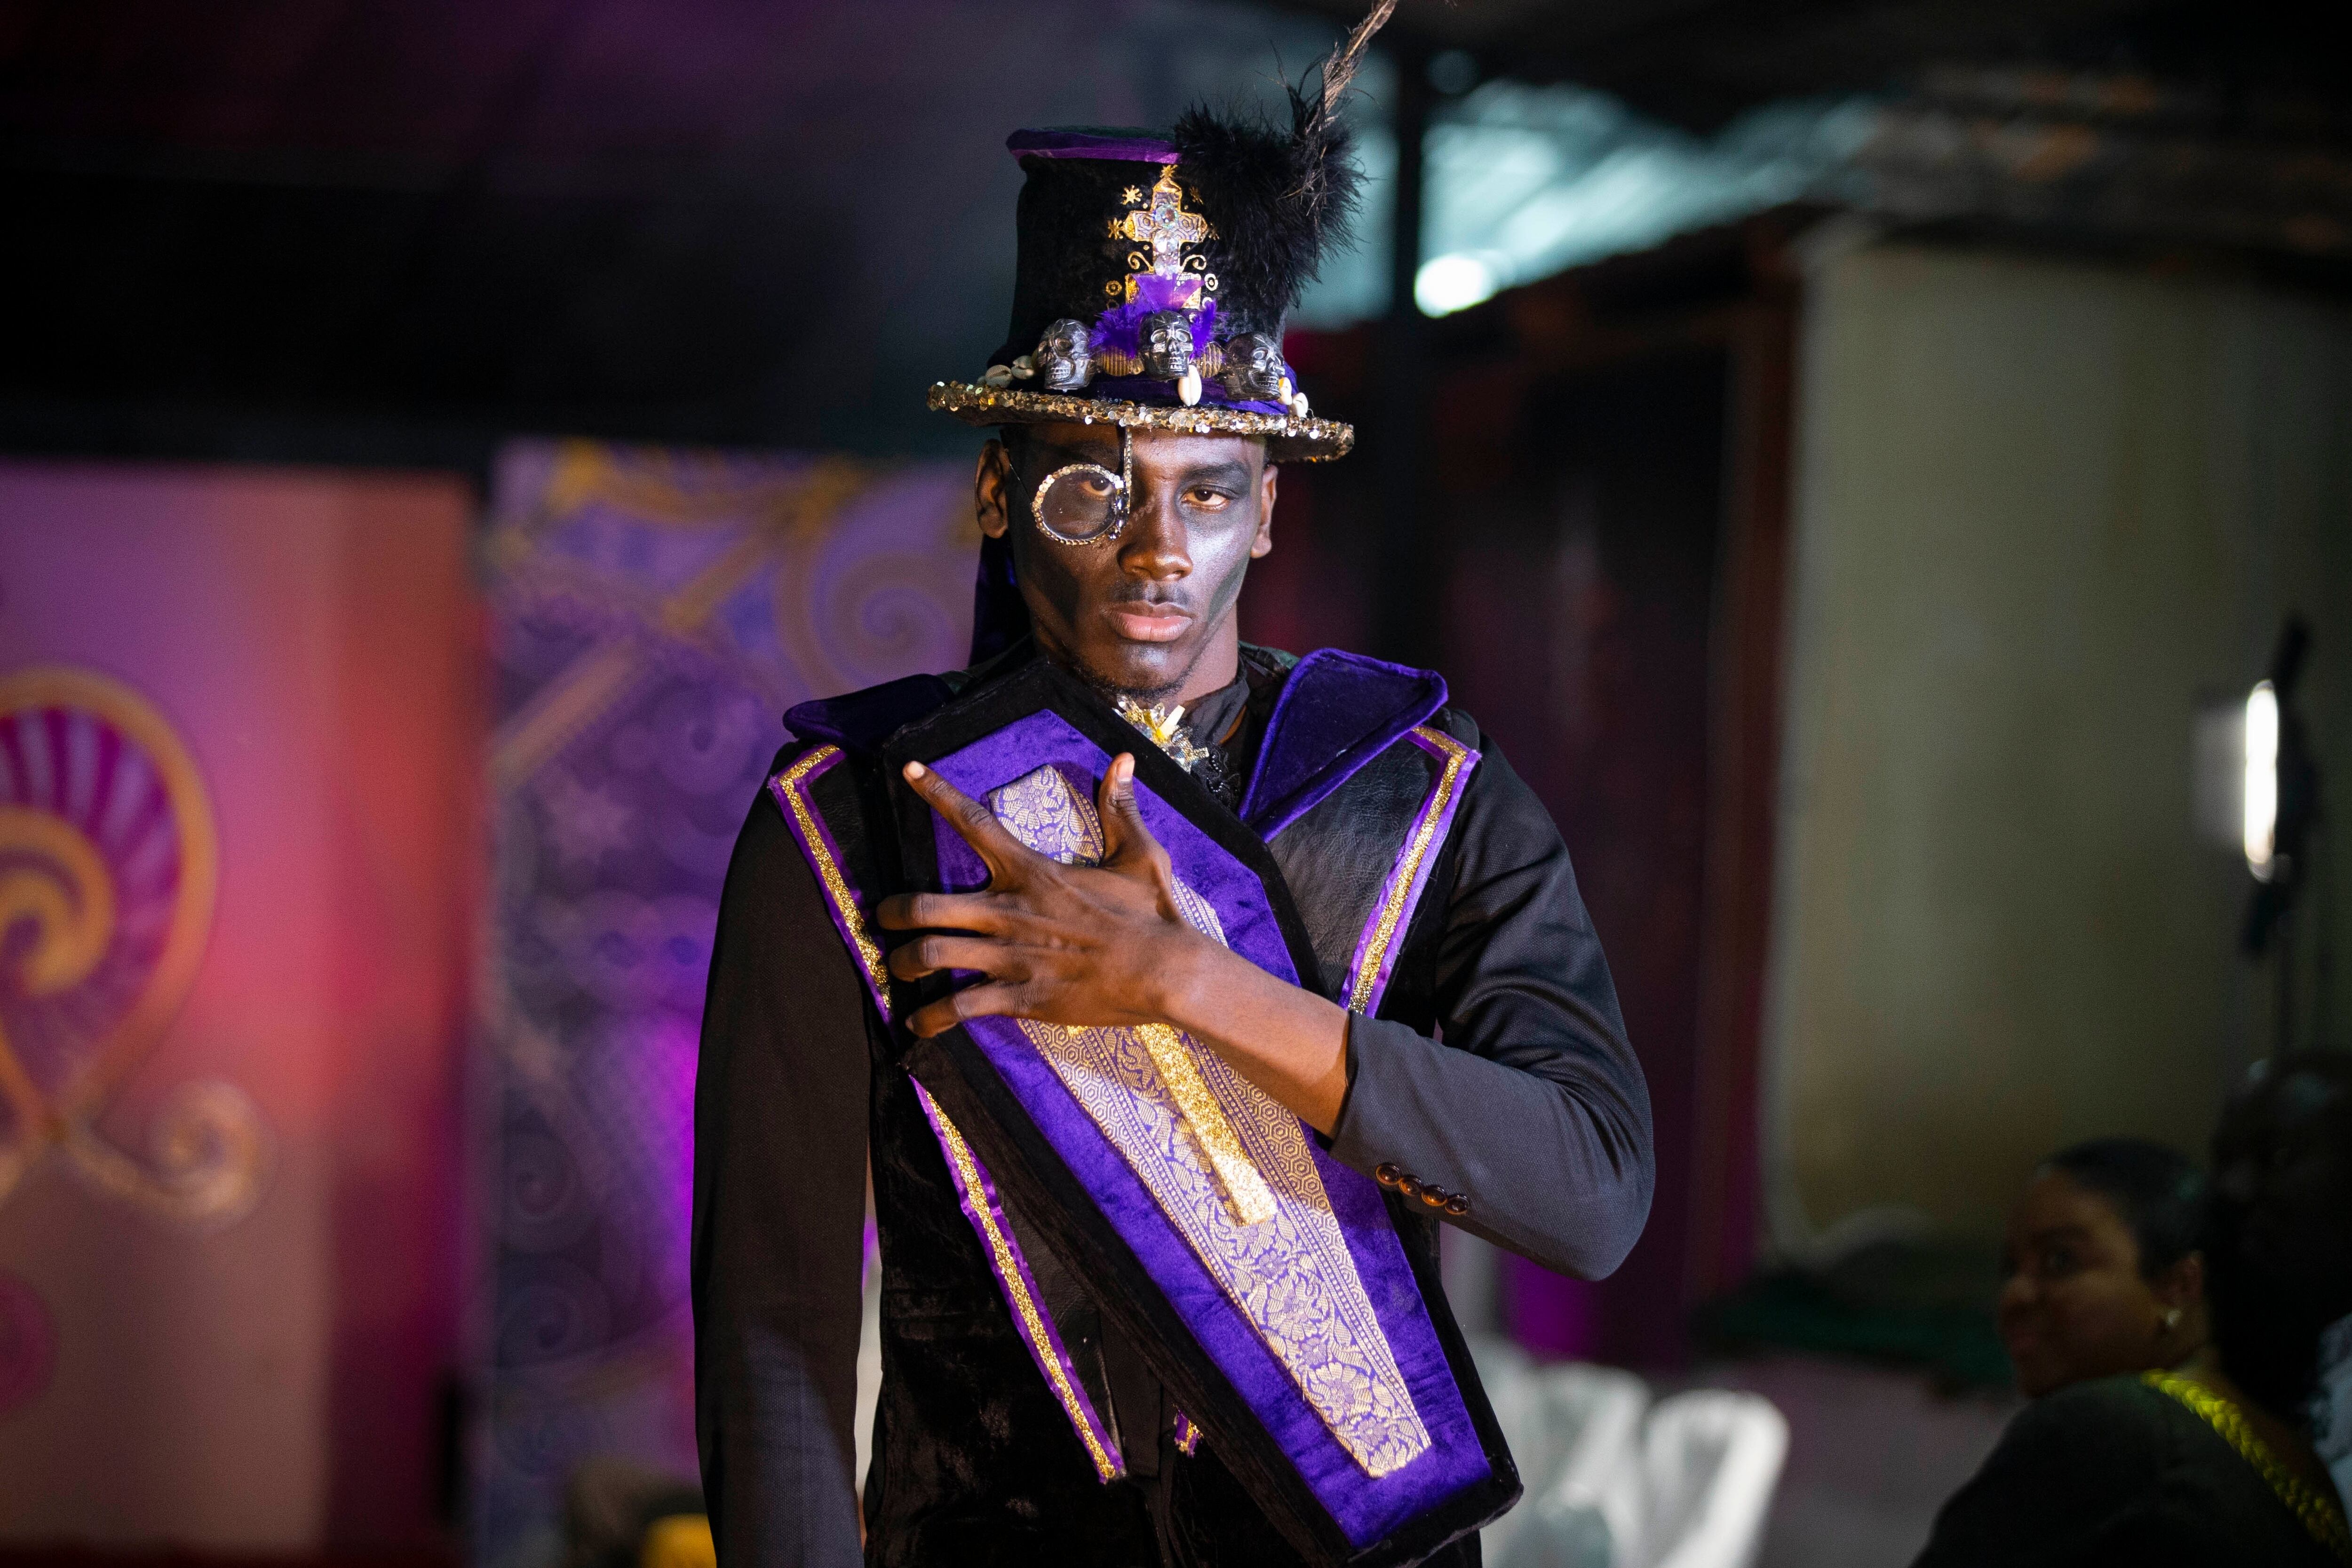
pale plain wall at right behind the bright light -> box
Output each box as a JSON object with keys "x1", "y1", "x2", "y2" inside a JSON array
[{"x1": 1766, "y1": 245, "x2": 2352, "y2": 1241}]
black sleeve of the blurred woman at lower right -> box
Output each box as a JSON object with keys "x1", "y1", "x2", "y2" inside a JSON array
[{"x1": 1912, "y1": 1382, "x2": 2180, "y2": 1568}]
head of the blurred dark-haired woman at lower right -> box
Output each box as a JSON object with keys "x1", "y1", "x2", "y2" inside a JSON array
[{"x1": 1999, "y1": 1138, "x2": 2206, "y2": 1399}]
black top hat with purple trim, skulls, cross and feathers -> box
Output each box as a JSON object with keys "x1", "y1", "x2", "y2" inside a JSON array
[{"x1": 929, "y1": 0, "x2": 1395, "y2": 461}]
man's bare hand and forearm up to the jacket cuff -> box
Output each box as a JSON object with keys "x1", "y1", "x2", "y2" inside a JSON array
[{"x1": 877, "y1": 752, "x2": 1348, "y2": 1133}]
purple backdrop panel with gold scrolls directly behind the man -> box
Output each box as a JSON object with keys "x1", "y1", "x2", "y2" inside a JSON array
[{"x1": 475, "y1": 442, "x2": 978, "y2": 1568}]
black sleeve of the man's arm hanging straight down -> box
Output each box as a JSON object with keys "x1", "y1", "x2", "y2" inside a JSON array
[{"x1": 691, "y1": 790, "x2": 868, "y2": 1568}]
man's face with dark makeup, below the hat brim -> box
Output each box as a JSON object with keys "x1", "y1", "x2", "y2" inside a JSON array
[{"x1": 976, "y1": 423, "x2": 1277, "y2": 698}]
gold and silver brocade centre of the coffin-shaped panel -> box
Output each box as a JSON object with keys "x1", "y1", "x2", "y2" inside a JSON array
[{"x1": 988, "y1": 769, "x2": 1430, "y2": 1476}]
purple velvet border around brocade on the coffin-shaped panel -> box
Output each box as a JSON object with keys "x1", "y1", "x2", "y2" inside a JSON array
[{"x1": 931, "y1": 710, "x2": 1489, "y2": 1547}]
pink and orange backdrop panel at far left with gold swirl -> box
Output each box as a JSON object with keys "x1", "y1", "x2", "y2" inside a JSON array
[{"x1": 0, "y1": 463, "x2": 485, "y2": 1559}]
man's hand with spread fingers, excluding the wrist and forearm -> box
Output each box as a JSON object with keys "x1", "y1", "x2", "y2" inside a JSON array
[{"x1": 880, "y1": 752, "x2": 1230, "y2": 1037}]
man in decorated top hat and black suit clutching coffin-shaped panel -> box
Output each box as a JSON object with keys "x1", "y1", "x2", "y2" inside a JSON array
[{"x1": 694, "y1": 26, "x2": 1651, "y2": 1568}]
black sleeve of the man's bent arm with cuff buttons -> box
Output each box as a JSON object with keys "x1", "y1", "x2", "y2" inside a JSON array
[{"x1": 1331, "y1": 736, "x2": 1653, "y2": 1279}]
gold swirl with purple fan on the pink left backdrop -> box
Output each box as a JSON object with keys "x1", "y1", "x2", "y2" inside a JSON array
[{"x1": 0, "y1": 668, "x2": 270, "y2": 1227}]
